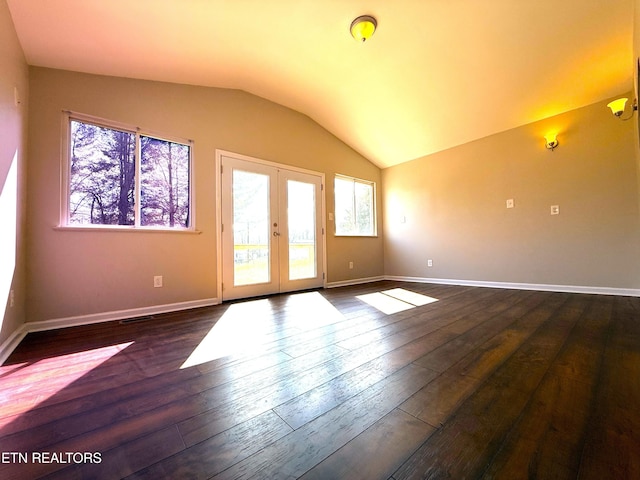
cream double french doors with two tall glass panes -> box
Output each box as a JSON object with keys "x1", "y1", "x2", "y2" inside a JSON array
[{"x1": 220, "y1": 155, "x2": 324, "y2": 300}]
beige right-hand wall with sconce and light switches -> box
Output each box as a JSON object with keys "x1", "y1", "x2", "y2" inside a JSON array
[{"x1": 383, "y1": 97, "x2": 640, "y2": 289}]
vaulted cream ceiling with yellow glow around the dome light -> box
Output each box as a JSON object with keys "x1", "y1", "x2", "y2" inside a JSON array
[{"x1": 7, "y1": 0, "x2": 634, "y2": 167}]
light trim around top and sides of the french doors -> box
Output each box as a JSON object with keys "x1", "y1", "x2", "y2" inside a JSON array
[{"x1": 215, "y1": 149, "x2": 327, "y2": 299}]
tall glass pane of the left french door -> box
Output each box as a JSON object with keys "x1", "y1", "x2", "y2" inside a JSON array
[{"x1": 232, "y1": 170, "x2": 271, "y2": 286}]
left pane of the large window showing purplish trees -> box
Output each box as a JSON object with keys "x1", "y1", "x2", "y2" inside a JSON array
[{"x1": 69, "y1": 120, "x2": 135, "y2": 225}]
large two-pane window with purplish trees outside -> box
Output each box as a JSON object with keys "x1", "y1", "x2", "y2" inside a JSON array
[{"x1": 63, "y1": 116, "x2": 192, "y2": 229}]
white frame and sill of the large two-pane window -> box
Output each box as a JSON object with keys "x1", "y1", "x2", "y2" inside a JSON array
[{"x1": 58, "y1": 111, "x2": 199, "y2": 233}]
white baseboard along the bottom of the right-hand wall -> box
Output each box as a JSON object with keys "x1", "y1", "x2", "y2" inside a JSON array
[{"x1": 384, "y1": 275, "x2": 640, "y2": 297}]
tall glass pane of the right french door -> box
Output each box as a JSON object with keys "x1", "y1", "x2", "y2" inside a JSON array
[{"x1": 287, "y1": 180, "x2": 317, "y2": 280}]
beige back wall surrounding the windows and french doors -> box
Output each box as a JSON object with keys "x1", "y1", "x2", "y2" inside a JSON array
[{"x1": 27, "y1": 67, "x2": 383, "y2": 321}]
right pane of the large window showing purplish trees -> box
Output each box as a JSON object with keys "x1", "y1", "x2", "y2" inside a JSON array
[{"x1": 140, "y1": 136, "x2": 190, "y2": 227}]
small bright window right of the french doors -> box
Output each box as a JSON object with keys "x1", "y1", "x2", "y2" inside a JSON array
[{"x1": 334, "y1": 175, "x2": 376, "y2": 236}]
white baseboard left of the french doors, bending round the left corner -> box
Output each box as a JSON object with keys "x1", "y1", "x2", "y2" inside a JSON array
[{"x1": 0, "y1": 298, "x2": 220, "y2": 365}]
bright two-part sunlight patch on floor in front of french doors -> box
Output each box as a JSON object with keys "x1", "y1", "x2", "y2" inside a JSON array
[{"x1": 180, "y1": 292, "x2": 343, "y2": 369}]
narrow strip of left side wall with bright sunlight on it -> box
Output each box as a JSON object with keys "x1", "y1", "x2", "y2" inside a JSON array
[{"x1": 0, "y1": 0, "x2": 29, "y2": 344}]
